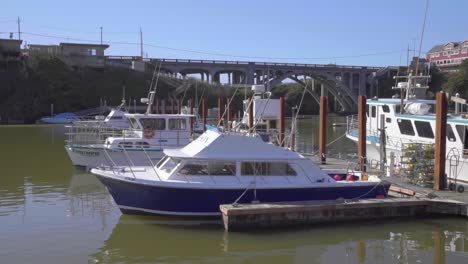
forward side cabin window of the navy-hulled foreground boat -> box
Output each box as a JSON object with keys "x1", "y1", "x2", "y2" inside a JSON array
[{"x1": 177, "y1": 161, "x2": 236, "y2": 176}]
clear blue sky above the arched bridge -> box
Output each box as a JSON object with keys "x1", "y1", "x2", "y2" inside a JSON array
[{"x1": 0, "y1": 0, "x2": 468, "y2": 66}]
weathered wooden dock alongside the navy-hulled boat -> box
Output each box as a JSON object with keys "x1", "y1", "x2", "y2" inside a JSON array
[{"x1": 220, "y1": 158, "x2": 468, "y2": 231}]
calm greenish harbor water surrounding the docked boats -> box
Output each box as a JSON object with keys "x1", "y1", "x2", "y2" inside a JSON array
[{"x1": 0, "y1": 116, "x2": 468, "y2": 263}]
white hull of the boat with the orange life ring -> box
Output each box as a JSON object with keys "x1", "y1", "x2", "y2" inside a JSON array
[{"x1": 65, "y1": 145, "x2": 164, "y2": 170}]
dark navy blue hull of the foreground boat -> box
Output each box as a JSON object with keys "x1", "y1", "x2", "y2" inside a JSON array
[{"x1": 96, "y1": 175, "x2": 390, "y2": 216}]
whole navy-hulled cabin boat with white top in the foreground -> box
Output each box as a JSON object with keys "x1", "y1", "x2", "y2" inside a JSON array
[{"x1": 91, "y1": 130, "x2": 390, "y2": 216}]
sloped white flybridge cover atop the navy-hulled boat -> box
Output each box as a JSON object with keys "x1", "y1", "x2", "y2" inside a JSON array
[{"x1": 164, "y1": 130, "x2": 304, "y2": 160}]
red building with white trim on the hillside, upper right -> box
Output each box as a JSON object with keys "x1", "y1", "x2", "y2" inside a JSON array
[{"x1": 426, "y1": 40, "x2": 468, "y2": 71}]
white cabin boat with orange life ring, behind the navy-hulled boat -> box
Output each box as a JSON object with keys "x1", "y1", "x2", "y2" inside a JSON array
[{"x1": 65, "y1": 114, "x2": 193, "y2": 169}]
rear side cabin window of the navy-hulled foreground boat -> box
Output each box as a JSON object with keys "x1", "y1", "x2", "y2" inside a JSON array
[{"x1": 241, "y1": 162, "x2": 297, "y2": 176}]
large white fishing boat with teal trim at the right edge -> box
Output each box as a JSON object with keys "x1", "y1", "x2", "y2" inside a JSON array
[{"x1": 346, "y1": 75, "x2": 468, "y2": 192}]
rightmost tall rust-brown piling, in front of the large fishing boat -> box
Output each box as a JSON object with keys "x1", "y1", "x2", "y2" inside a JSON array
[{"x1": 433, "y1": 92, "x2": 447, "y2": 190}]
